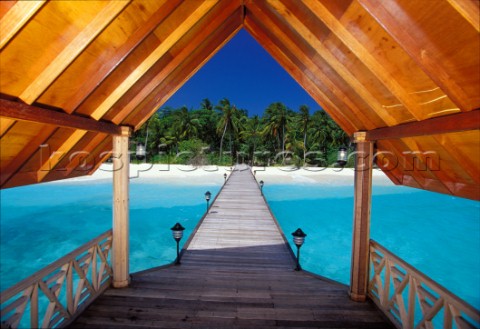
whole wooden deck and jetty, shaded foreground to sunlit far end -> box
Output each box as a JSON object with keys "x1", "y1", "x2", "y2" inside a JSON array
[{"x1": 72, "y1": 170, "x2": 393, "y2": 329}]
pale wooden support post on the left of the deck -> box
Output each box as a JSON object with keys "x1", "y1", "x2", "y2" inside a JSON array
[{"x1": 112, "y1": 127, "x2": 130, "y2": 288}]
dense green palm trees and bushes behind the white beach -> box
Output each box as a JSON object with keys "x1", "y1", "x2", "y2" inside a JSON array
[{"x1": 132, "y1": 99, "x2": 349, "y2": 167}]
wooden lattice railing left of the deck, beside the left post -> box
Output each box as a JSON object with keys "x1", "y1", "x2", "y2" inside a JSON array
[{"x1": 0, "y1": 230, "x2": 112, "y2": 328}]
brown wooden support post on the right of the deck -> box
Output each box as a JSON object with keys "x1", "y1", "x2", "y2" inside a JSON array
[{"x1": 350, "y1": 132, "x2": 373, "y2": 302}]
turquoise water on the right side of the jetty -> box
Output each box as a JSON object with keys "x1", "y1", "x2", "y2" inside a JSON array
[{"x1": 264, "y1": 184, "x2": 480, "y2": 308}]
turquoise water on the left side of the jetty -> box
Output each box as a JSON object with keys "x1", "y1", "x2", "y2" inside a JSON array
[{"x1": 0, "y1": 179, "x2": 220, "y2": 291}]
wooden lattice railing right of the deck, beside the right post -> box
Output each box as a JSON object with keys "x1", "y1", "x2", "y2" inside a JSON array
[{"x1": 369, "y1": 241, "x2": 480, "y2": 329}]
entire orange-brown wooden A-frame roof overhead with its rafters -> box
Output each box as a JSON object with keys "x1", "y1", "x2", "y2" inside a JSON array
[{"x1": 0, "y1": 0, "x2": 480, "y2": 200}]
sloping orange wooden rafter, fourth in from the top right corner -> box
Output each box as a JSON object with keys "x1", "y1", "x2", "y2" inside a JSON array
[{"x1": 260, "y1": 0, "x2": 397, "y2": 126}]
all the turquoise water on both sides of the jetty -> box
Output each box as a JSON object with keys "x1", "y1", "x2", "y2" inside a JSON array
[{"x1": 0, "y1": 179, "x2": 480, "y2": 308}]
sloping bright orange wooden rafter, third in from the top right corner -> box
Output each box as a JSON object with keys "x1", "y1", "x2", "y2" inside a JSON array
[{"x1": 304, "y1": 0, "x2": 422, "y2": 120}]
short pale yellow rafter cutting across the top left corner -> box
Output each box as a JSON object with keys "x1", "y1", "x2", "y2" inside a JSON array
[{"x1": 0, "y1": 0, "x2": 46, "y2": 50}]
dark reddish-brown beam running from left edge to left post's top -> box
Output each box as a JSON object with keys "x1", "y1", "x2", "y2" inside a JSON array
[{"x1": 0, "y1": 99, "x2": 120, "y2": 135}]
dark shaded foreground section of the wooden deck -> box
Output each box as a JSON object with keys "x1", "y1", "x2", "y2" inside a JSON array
[{"x1": 71, "y1": 244, "x2": 393, "y2": 329}]
